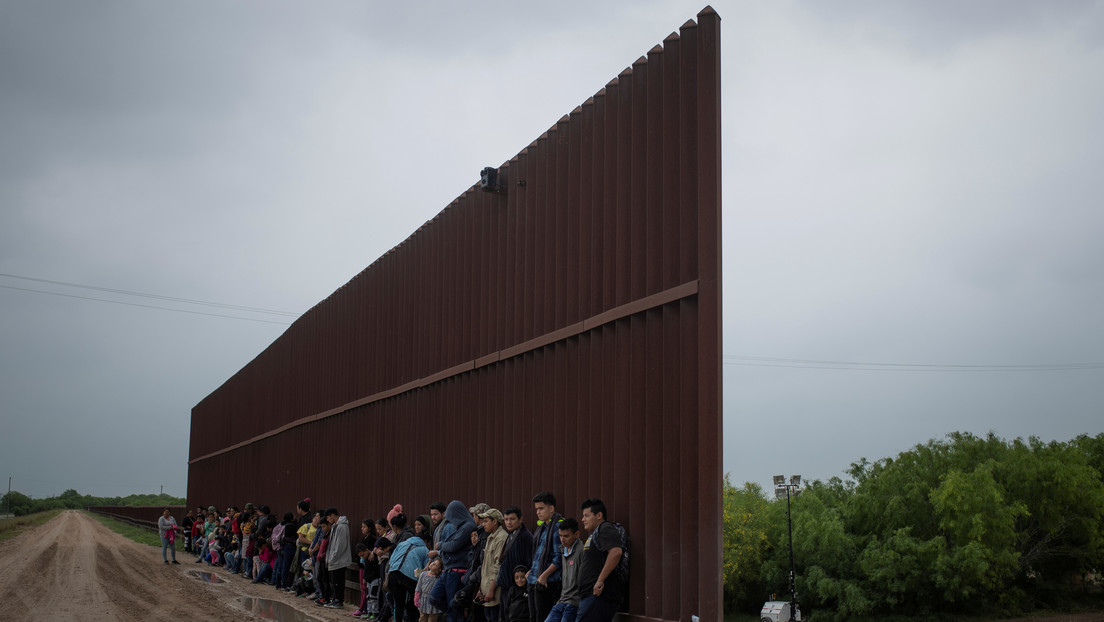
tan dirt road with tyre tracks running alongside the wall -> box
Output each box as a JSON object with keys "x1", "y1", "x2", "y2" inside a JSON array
[{"x1": 0, "y1": 512, "x2": 353, "y2": 622}]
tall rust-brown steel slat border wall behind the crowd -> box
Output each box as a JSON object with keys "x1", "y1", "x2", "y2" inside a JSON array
[{"x1": 188, "y1": 8, "x2": 721, "y2": 620}]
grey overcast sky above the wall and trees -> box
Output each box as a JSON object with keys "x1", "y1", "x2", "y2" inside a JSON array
[{"x1": 0, "y1": 0, "x2": 1104, "y2": 497}]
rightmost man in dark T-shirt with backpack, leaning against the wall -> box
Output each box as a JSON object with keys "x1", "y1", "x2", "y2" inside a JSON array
[{"x1": 576, "y1": 498, "x2": 625, "y2": 622}]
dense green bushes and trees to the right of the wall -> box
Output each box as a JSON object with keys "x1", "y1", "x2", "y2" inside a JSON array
[{"x1": 724, "y1": 433, "x2": 1104, "y2": 620}]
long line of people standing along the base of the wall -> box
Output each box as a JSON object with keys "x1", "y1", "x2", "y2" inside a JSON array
[{"x1": 158, "y1": 493, "x2": 629, "y2": 622}]
